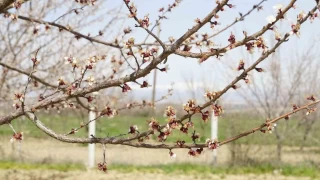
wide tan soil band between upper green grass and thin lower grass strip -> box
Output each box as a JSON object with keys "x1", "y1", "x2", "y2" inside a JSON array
[{"x1": 0, "y1": 138, "x2": 320, "y2": 165}]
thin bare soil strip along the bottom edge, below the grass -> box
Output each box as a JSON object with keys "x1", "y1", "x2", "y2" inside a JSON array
[{"x1": 0, "y1": 170, "x2": 310, "y2": 180}]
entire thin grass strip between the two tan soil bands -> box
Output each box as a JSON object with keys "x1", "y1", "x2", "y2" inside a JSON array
[{"x1": 0, "y1": 161, "x2": 320, "y2": 178}]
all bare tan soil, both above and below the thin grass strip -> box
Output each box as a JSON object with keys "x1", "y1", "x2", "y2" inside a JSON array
[{"x1": 0, "y1": 137, "x2": 320, "y2": 180}]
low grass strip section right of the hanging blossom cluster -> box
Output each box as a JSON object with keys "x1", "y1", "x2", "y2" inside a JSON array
[{"x1": 110, "y1": 164, "x2": 320, "y2": 178}]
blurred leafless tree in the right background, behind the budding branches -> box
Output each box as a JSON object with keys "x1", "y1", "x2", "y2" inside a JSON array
[{"x1": 231, "y1": 37, "x2": 320, "y2": 161}]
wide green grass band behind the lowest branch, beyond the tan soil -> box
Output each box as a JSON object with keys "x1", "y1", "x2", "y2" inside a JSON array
[{"x1": 0, "y1": 113, "x2": 320, "y2": 146}]
